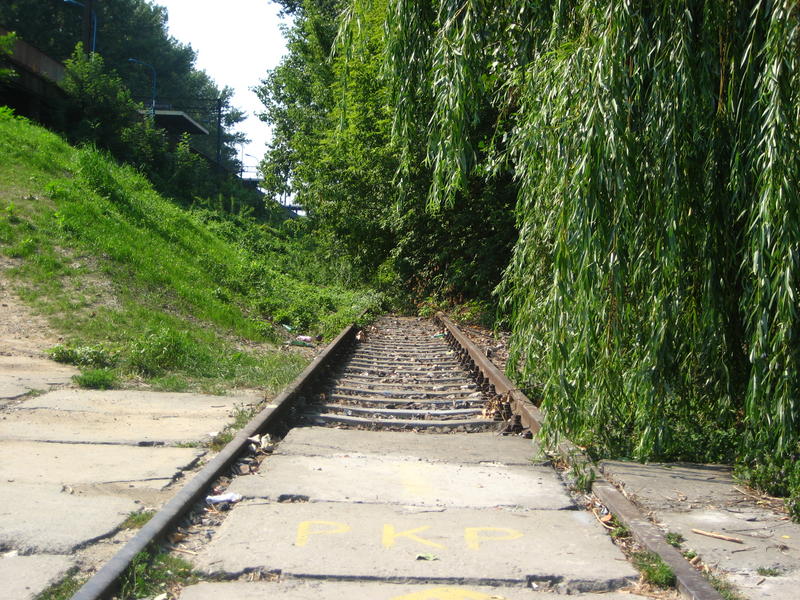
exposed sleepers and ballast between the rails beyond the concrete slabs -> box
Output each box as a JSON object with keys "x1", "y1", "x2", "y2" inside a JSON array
[{"x1": 306, "y1": 317, "x2": 500, "y2": 432}]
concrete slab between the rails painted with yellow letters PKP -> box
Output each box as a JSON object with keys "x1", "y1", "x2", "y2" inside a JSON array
[{"x1": 196, "y1": 502, "x2": 638, "y2": 592}]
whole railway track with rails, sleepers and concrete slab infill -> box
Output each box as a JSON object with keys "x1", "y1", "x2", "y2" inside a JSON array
[{"x1": 73, "y1": 317, "x2": 715, "y2": 600}]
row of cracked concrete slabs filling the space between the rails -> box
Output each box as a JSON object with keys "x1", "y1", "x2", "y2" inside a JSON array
[{"x1": 188, "y1": 427, "x2": 638, "y2": 600}]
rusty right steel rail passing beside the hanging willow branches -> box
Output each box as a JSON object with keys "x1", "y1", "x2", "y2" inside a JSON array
[{"x1": 435, "y1": 312, "x2": 723, "y2": 600}]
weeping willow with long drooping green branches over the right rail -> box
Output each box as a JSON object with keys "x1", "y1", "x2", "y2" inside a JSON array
[{"x1": 366, "y1": 0, "x2": 800, "y2": 508}]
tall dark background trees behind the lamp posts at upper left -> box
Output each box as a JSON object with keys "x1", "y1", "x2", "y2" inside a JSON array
[{"x1": 0, "y1": 0, "x2": 244, "y2": 172}]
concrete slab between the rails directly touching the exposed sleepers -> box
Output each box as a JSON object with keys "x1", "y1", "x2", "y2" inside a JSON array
[{"x1": 275, "y1": 427, "x2": 542, "y2": 465}]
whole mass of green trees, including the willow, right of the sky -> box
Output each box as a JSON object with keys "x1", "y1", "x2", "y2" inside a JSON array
[{"x1": 264, "y1": 0, "x2": 800, "y2": 516}]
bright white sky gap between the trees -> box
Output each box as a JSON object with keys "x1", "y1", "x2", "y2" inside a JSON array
[{"x1": 152, "y1": 0, "x2": 286, "y2": 176}]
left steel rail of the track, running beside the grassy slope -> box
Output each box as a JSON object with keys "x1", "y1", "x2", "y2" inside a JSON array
[{"x1": 72, "y1": 325, "x2": 356, "y2": 600}]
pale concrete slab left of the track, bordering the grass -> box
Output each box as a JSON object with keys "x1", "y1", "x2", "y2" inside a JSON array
[{"x1": 0, "y1": 390, "x2": 257, "y2": 445}]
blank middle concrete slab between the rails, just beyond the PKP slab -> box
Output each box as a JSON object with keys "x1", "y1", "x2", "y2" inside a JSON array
[{"x1": 229, "y1": 454, "x2": 575, "y2": 510}]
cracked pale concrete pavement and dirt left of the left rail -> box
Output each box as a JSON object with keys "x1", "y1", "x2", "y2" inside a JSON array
[{"x1": 0, "y1": 280, "x2": 261, "y2": 600}]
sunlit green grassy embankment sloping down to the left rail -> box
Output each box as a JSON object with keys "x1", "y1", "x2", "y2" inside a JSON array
[{"x1": 0, "y1": 107, "x2": 378, "y2": 392}]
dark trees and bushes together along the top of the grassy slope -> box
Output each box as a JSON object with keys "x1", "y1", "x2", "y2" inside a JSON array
[{"x1": 0, "y1": 0, "x2": 268, "y2": 219}]
